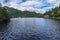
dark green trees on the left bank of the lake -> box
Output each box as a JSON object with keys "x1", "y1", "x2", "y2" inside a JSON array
[{"x1": 0, "y1": 4, "x2": 10, "y2": 21}]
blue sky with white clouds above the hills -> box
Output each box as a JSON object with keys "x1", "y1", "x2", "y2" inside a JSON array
[{"x1": 0, "y1": 0, "x2": 60, "y2": 13}]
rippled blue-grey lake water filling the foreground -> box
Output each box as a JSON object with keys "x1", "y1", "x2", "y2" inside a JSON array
[{"x1": 0, "y1": 18, "x2": 60, "y2": 40}]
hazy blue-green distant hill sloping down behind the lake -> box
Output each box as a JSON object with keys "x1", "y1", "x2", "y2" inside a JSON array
[{"x1": 5, "y1": 7, "x2": 43, "y2": 17}]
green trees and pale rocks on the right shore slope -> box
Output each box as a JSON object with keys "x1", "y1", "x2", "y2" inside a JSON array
[{"x1": 43, "y1": 6, "x2": 60, "y2": 19}]
